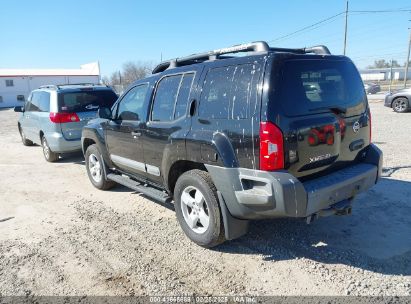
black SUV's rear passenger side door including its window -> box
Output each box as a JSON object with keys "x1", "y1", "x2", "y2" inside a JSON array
[{"x1": 144, "y1": 71, "x2": 199, "y2": 183}]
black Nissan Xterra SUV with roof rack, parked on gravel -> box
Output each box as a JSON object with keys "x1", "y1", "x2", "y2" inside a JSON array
[{"x1": 82, "y1": 42, "x2": 382, "y2": 247}]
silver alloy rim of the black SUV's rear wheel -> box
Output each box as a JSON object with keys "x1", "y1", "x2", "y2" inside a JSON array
[{"x1": 180, "y1": 186, "x2": 210, "y2": 234}]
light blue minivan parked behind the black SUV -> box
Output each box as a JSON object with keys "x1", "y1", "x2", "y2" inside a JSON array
[{"x1": 14, "y1": 84, "x2": 117, "y2": 162}]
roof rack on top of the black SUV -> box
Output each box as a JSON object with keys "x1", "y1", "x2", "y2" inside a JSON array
[{"x1": 152, "y1": 41, "x2": 331, "y2": 74}]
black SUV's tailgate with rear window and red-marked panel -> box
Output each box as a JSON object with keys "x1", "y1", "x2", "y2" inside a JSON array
[{"x1": 268, "y1": 58, "x2": 370, "y2": 177}]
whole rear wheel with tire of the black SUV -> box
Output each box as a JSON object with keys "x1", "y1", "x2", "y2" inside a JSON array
[{"x1": 174, "y1": 170, "x2": 225, "y2": 248}]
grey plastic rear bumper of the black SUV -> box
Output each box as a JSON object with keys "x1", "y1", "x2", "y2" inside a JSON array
[{"x1": 206, "y1": 145, "x2": 382, "y2": 219}]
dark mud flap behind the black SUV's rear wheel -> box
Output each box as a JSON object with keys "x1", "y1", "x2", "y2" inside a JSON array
[{"x1": 217, "y1": 191, "x2": 249, "y2": 240}]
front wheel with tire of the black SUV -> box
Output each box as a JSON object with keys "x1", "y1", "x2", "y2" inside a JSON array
[{"x1": 85, "y1": 144, "x2": 116, "y2": 190}]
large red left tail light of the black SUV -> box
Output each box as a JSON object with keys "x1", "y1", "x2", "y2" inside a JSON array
[{"x1": 260, "y1": 122, "x2": 284, "y2": 171}]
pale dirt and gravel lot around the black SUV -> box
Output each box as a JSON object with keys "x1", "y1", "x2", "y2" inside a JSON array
[{"x1": 0, "y1": 102, "x2": 411, "y2": 295}]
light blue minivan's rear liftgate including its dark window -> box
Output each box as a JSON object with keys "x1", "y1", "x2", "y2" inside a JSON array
[{"x1": 58, "y1": 88, "x2": 117, "y2": 140}]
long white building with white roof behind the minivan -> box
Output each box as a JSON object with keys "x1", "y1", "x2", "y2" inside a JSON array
[{"x1": 0, "y1": 62, "x2": 100, "y2": 108}]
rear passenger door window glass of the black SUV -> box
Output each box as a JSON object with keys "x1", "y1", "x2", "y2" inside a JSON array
[{"x1": 151, "y1": 75, "x2": 182, "y2": 121}]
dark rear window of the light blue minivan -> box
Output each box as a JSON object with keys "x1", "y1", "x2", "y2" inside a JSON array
[{"x1": 58, "y1": 90, "x2": 117, "y2": 112}]
